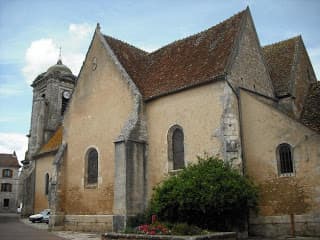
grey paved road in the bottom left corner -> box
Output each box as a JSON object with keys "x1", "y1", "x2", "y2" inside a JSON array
[{"x1": 0, "y1": 214, "x2": 65, "y2": 240}]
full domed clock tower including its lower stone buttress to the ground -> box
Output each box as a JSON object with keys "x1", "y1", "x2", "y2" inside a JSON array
[{"x1": 20, "y1": 57, "x2": 76, "y2": 216}]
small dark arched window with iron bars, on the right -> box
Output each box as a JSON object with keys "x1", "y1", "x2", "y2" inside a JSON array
[{"x1": 277, "y1": 143, "x2": 293, "y2": 174}]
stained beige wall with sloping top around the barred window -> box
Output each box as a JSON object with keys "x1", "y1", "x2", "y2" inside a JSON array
[{"x1": 240, "y1": 91, "x2": 320, "y2": 236}]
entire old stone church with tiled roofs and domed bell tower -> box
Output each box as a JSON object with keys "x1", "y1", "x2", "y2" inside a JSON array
[{"x1": 25, "y1": 8, "x2": 320, "y2": 236}]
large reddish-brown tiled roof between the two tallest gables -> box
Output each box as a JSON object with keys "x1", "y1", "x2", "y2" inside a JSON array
[{"x1": 105, "y1": 10, "x2": 248, "y2": 99}]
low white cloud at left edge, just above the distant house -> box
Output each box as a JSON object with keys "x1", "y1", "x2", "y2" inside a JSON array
[{"x1": 0, "y1": 133, "x2": 28, "y2": 161}]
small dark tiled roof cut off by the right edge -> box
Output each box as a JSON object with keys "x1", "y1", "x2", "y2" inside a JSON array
[{"x1": 301, "y1": 81, "x2": 320, "y2": 133}]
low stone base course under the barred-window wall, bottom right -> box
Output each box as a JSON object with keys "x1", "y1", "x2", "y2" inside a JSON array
[{"x1": 249, "y1": 214, "x2": 320, "y2": 237}]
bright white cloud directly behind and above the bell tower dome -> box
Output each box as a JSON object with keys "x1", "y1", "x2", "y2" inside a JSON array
[{"x1": 22, "y1": 23, "x2": 94, "y2": 84}]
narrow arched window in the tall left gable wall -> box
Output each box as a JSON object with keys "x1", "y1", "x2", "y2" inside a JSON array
[{"x1": 86, "y1": 148, "x2": 98, "y2": 185}]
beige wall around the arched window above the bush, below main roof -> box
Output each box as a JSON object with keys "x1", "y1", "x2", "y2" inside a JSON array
[{"x1": 146, "y1": 81, "x2": 228, "y2": 197}]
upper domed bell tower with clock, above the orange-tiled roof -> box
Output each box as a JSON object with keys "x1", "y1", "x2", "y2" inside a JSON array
[{"x1": 28, "y1": 58, "x2": 76, "y2": 160}]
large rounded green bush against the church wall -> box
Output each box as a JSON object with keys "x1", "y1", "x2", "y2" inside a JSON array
[{"x1": 148, "y1": 157, "x2": 258, "y2": 230}]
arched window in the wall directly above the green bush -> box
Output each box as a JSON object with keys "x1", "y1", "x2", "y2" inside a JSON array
[{"x1": 168, "y1": 125, "x2": 185, "y2": 170}]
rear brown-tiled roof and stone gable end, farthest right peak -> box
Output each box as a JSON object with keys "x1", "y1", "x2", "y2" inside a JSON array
[{"x1": 263, "y1": 36, "x2": 316, "y2": 119}]
